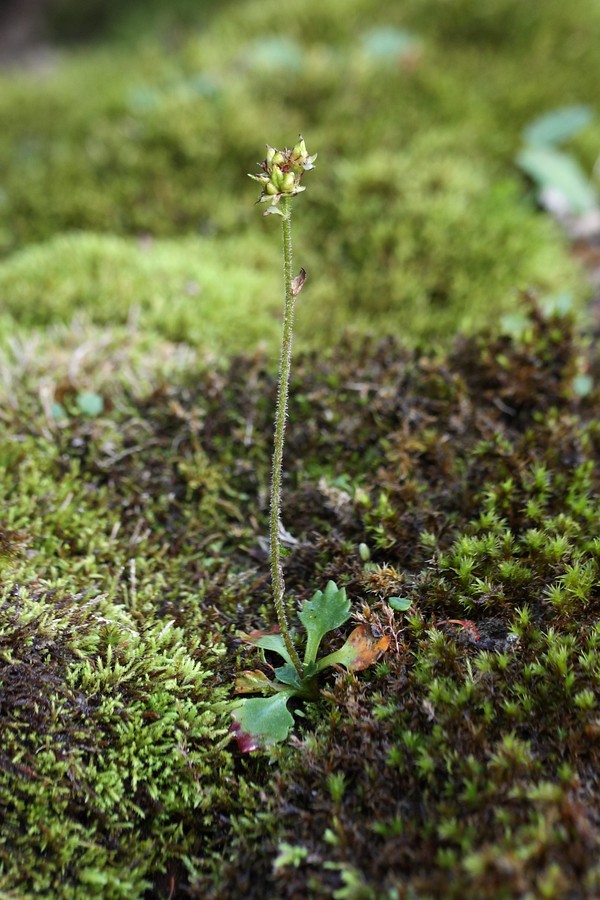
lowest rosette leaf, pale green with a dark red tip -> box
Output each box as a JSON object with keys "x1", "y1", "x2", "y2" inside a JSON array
[{"x1": 231, "y1": 693, "x2": 294, "y2": 753}]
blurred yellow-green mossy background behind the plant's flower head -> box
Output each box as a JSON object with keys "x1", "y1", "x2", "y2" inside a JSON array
[{"x1": 0, "y1": 0, "x2": 600, "y2": 351}]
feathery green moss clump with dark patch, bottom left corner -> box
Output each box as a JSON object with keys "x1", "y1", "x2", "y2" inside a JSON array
[{"x1": 0, "y1": 585, "x2": 231, "y2": 897}]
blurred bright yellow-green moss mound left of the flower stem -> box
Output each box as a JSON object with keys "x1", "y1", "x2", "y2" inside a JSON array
[{"x1": 0, "y1": 234, "x2": 279, "y2": 353}]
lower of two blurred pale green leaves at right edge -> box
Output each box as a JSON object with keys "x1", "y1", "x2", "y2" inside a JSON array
[{"x1": 515, "y1": 146, "x2": 598, "y2": 214}]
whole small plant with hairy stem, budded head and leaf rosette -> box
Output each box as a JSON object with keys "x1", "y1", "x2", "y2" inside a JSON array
[{"x1": 232, "y1": 135, "x2": 389, "y2": 753}]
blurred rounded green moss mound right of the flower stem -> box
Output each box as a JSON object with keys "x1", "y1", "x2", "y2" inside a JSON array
[{"x1": 298, "y1": 132, "x2": 582, "y2": 340}]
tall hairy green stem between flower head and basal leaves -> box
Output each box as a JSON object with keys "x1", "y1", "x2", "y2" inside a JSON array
[{"x1": 270, "y1": 197, "x2": 304, "y2": 678}]
